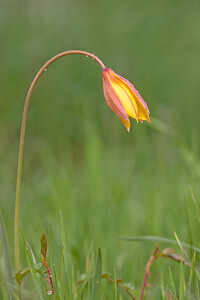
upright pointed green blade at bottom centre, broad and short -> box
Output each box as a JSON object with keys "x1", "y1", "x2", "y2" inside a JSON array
[{"x1": 92, "y1": 248, "x2": 102, "y2": 300}]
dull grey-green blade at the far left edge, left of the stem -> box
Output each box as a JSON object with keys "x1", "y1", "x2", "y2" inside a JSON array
[{"x1": 0, "y1": 212, "x2": 14, "y2": 299}]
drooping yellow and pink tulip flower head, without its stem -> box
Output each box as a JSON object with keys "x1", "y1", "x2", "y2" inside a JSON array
[{"x1": 102, "y1": 68, "x2": 151, "y2": 131}]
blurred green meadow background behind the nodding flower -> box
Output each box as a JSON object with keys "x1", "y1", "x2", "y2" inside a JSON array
[{"x1": 0, "y1": 0, "x2": 200, "y2": 296}]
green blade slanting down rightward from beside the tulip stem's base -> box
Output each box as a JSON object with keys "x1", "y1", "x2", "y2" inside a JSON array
[{"x1": 20, "y1": 227, "x2": 44, "y2": 300}]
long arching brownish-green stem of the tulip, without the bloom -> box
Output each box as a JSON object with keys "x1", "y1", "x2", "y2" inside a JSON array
[{"x1": 14, "y1": 50, "x2": 105, "y2": 271}]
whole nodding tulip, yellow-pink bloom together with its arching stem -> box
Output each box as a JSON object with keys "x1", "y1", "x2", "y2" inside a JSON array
[{"x1": 15, "y1": 50, "x2": 150, "y2": 276}]
